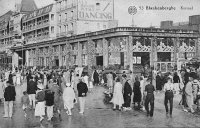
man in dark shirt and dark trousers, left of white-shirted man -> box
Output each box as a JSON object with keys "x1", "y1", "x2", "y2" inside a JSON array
[{"x1": 145, "y1": 77, "x2": 155, "y2": 117}]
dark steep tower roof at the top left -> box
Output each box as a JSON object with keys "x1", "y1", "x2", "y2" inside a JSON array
[{"x1": 20, "y1": 0, "x2": 37, "y2": 12}]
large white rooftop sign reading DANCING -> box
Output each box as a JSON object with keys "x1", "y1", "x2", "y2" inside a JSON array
[{"x1": 78, "y1": 0, "x2": 113, "y2": 20}]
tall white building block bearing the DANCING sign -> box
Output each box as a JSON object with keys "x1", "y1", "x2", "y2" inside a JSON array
[{"x1": 56, "y1": 0, "x2": 117, "y2": 37}]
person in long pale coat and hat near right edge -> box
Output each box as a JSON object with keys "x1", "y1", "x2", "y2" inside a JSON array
[{"x1": 185, "y1": 73, "x2": 194, "y2": 113}]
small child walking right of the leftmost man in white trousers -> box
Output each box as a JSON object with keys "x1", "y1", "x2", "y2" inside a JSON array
[{"x1": 21, "y1": 91, "x2": 30, "y2": 117}]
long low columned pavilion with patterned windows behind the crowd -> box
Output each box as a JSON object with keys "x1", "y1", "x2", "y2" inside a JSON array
[{"x1": 13, "y1": 27, "x2": 200, "y2": 73}]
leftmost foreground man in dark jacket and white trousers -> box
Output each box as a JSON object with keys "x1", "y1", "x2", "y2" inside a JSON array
[{"x1": 3, "y1": 81, "x2": 16, "y2": 118}]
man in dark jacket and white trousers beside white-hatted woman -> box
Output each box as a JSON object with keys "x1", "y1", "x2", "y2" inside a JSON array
[{"x1": 77, "y1": 78, "x2": 88, "y2": 114}]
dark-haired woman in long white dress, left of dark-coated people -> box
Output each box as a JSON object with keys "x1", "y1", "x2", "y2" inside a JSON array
[{"x1": 111, "y1": 78, "x2": 124, "y2": 111}]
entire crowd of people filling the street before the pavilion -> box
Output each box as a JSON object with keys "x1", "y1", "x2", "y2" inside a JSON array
[{"x1": 0, "y1": 65, "x2": 200, "y2": 121}]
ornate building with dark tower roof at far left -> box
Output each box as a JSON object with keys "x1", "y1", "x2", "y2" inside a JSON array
[{"x1": 0, "y1": 0, "x2": 37, "y2": 67}]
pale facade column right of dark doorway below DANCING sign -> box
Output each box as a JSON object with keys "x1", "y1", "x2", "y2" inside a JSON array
[{"x1": 103, "y1": 38, "x2": 108, "y2": 67}]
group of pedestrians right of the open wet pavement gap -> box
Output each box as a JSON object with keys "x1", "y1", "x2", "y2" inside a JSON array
[{"x1": 107, "y1": 69, "x2": 200, "y2": 117}]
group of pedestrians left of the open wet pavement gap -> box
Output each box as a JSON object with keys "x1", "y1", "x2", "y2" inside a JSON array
[{"x1": 0, "y1": 69, "x2": 89, "y2": 121}]
